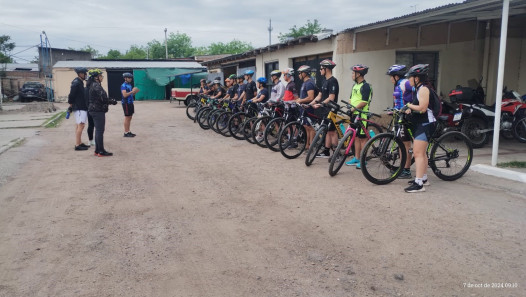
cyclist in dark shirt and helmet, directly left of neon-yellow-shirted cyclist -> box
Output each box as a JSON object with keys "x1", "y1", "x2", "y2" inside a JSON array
[{"x1": 310, "y1": 59, "x2": 340, "y2": 158}]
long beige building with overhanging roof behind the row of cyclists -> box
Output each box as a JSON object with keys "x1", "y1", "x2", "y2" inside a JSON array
[{"x1": 203, "y1": 0, "x2": 526, "y2": 112}]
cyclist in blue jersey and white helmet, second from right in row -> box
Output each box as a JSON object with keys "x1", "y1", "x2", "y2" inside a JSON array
[{"x1": 386, "y1": 65, "x2": 413, "y2": 179}]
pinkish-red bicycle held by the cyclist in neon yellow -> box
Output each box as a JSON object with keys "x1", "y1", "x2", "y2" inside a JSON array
[{"x1": 329, "y1": 103, "x2": 383, "y2": 176}]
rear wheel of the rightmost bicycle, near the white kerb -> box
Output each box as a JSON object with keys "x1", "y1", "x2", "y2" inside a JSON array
[{"x1": 429, "y1": 131, "x2": 473, "y2": 181}]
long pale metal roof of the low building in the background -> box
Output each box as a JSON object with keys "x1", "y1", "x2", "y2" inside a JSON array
[{"x1": 53, "y1": 61, "x2": 205, "y2": 69}]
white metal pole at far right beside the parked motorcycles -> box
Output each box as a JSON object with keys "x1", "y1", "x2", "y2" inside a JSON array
[{"x1": 491, "y1": 0, "x2": 510, "y2": 166}]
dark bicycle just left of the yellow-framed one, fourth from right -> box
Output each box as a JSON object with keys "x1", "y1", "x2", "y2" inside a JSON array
[{"x1": 278, "y1": 104, "x2": 320, "y2": 159}]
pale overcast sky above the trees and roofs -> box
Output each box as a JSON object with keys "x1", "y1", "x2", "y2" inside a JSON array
[{"x1": 4, "y1": 0, "x2": 463, "y2": 63}]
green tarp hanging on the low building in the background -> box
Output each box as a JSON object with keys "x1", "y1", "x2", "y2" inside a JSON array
[{"x1": 133, "y1": 68, "x2": 207, "y2": 100}]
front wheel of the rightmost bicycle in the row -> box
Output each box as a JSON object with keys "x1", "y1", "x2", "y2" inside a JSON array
[{"x1": 360, "y1": 133, "x2": 407, "y2": 185}]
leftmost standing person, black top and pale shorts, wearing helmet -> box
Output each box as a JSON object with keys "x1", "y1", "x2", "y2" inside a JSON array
[{"x1": 68, "y1": 67, "x2": 93, "y2": 151}]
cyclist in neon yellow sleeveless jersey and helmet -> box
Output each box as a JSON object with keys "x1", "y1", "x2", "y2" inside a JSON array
[{"x1": 345, "y1": 64, "x2": 373, "y2": 169}]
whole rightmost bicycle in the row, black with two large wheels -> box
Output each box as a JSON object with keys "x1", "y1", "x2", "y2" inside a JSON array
[{"x1": 360, "y1": 109, "x2": 473, "y2": 185}]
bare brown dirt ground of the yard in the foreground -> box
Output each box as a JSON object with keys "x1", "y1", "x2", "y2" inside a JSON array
[{"x1": 0, "y1": 102, "x2": 526, "y2": 297}]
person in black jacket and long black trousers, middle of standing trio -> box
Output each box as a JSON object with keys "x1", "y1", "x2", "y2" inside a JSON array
[{"x1": 87, "y1": 69, "x2": 117, "y2": 157}]
